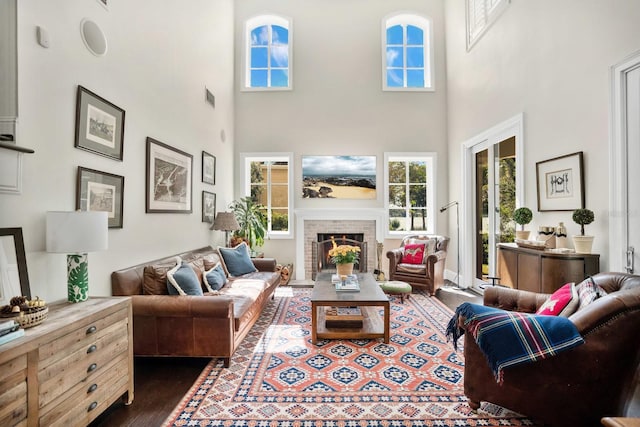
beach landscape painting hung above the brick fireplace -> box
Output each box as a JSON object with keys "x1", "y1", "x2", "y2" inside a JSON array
[{"x1": 302, "y1": 156, "x2": 376, "y2": 199}]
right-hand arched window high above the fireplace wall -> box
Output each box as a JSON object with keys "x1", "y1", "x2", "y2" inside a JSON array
[{"x1": 382, "y1": 13, "x2": 434, "y2": 91}]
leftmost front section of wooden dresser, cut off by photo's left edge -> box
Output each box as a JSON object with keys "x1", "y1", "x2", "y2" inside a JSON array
[{"x1": 0, "y1": 354, "x2": 27, "y2": 426}]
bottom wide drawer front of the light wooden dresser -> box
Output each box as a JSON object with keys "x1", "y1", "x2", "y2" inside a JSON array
[{"x1": 40, "y1": 354, "x2": 129, "y2": 427}]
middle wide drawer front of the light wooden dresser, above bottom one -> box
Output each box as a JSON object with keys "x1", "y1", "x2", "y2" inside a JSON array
[{"x1": 38, "y1": 319, "x2": 129, "y2": 408}]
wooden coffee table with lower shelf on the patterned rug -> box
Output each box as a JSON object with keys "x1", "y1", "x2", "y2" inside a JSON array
[{"x1": 311, "y1": 273, "x2": 390, "y2": 344}]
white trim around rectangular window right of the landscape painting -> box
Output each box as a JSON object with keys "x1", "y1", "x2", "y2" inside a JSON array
[{"x1": 383, "y1": 151, "x2": 438, "y2": 239}]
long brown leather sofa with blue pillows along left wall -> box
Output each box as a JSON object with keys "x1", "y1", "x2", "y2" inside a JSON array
[{"x1": 111, "y1": 246, "x2": 280, "y2": 367}]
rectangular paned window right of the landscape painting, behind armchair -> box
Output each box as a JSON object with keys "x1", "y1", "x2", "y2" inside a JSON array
[{"x1": 385, "y1": 153, "x2": 436, "y2": 236}]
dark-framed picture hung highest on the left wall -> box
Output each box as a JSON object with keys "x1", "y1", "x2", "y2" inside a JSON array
[{"x1": 75, "y1": 86, "x2": 124, "y2": 160}]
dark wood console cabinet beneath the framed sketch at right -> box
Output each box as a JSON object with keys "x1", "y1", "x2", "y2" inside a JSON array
[{"x1": 498, "y1": 243, "x2": 600, "y2": 294}]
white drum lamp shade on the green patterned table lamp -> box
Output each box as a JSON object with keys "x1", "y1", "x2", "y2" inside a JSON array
[{"x1": 47, "y1": 211, "x2": 109, "y2": 254}]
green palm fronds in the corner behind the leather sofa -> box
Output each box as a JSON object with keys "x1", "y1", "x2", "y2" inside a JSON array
[{"x1": 229, "y1": 197, "x2": 267, "y2": 251}]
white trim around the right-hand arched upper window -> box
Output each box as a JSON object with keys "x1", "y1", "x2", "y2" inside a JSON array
[{"x1": 380, "y1": 12, "x2": 436, "y2": 92}]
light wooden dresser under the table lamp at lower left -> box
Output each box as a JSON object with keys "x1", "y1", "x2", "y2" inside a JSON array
[{"x1": 0, "y1": 297, "x2": 133, "y2": 427}]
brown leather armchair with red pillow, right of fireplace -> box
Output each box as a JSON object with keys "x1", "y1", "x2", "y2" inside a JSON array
[{"x1": 387, "y1": 234, "x2": 449, "y2": 295}]
